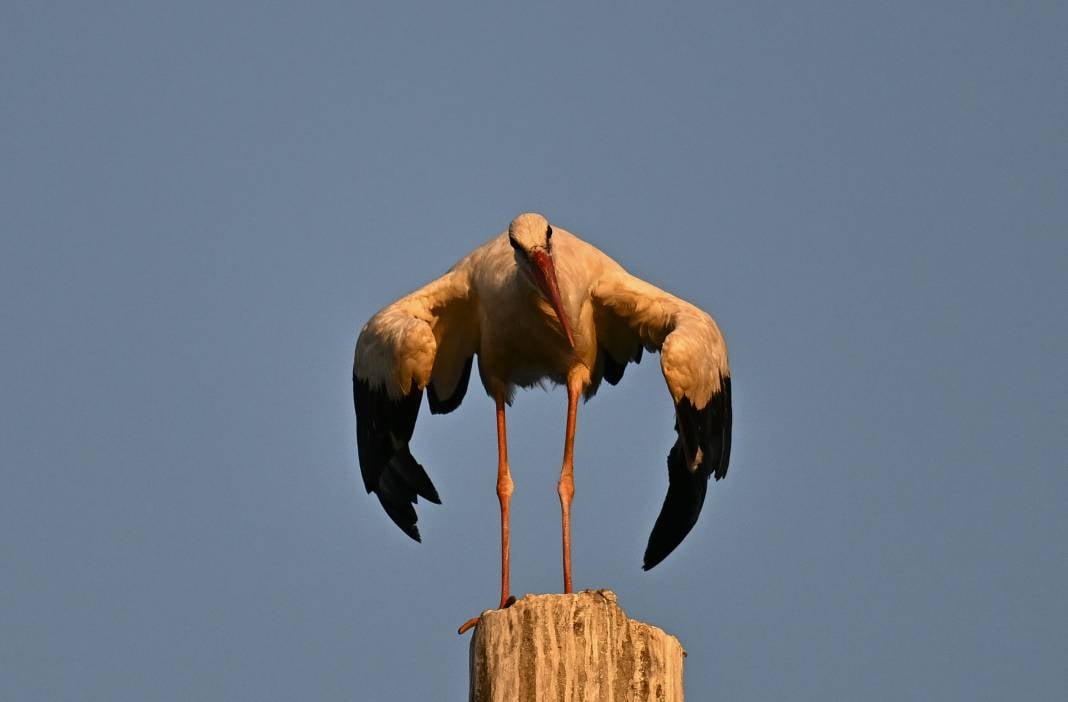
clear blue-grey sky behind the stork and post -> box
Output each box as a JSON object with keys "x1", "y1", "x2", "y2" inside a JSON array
[{"x1": 0, "y1": 1, "x2": 1068, "y2": 701}]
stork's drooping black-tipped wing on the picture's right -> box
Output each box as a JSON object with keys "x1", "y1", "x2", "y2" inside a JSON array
[{"x1": 592, "y1": 269, "x2": 731, "y2": 571}]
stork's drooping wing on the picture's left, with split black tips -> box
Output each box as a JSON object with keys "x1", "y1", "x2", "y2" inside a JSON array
[{"x1": 352, "y1": 265, "x2": 478, "y2": 541}]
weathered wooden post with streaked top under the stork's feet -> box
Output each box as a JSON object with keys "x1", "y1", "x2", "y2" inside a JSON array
[{"x1": 470, "y1": 590, "x2": 686, "y2": 702}]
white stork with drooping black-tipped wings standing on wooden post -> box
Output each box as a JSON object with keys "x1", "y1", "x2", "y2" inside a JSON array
[{"x1": 352, "y1": 213, "x2": 731, "y2": 631}]
